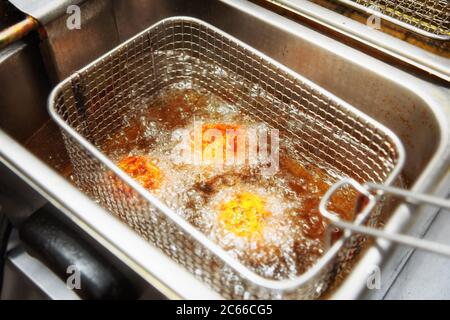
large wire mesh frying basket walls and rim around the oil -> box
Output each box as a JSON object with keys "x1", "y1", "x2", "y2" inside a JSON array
[{"x1": 49, "y1": 17, "x2": 404, "y2": 299}]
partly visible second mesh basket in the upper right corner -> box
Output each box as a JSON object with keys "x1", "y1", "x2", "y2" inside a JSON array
[{"x1": 338, "y1": 0, "x2": 450, "y2": 40}]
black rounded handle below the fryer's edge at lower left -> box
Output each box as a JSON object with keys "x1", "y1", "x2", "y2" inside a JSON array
[{"x1": 19, "y1": 204, "x2": 139, "y2": 299}]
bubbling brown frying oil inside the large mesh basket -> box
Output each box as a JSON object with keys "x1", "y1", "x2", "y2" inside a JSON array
[{"x1": 102, "y1": 88, "x2": 356, "y2": 279}]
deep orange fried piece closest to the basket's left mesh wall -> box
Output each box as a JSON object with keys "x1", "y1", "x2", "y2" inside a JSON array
[{"x1": 117, "y1": 156, "x2": 162, "y2": 190}]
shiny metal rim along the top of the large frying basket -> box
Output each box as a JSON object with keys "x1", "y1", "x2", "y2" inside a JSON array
[{"x1": 48, "y1": 16, "x2": 405, "y2": 291}]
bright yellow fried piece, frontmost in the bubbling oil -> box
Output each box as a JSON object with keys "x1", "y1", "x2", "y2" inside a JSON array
[{"x1": 218, "y1": 192, "x2": 271, "y2": 239}]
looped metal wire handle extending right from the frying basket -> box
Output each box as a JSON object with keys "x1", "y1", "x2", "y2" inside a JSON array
[{"x1": 319, "y1": 178, "x2": 450, "y2": 257}]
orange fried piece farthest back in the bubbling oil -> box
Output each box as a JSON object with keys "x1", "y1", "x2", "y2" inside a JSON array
[{"x1": 192, "y1": 123, "x2": 245, "y2": 162}]
